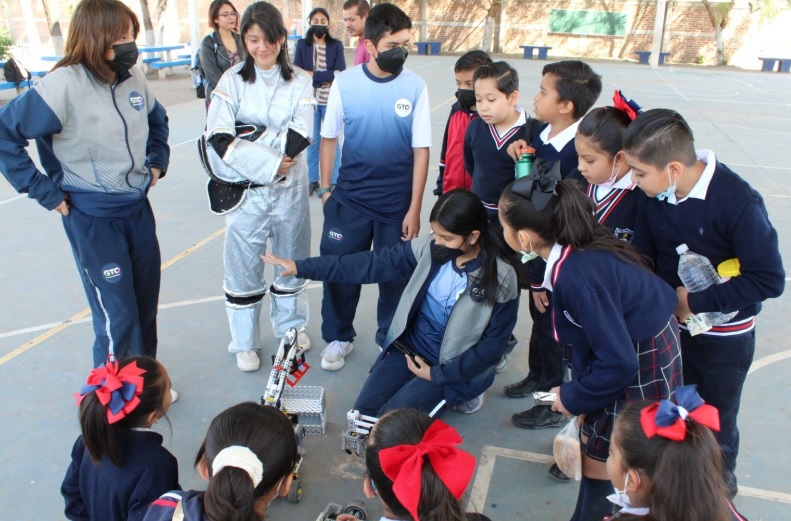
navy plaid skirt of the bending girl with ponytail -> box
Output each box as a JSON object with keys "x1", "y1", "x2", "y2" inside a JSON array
[{"x1": 580, "y1": 317, "x2": 683, "y2": 461}]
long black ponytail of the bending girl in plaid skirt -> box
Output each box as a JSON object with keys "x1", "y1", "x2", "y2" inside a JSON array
[{"x1": 499, "y1": 179, "x2": 648, "y2": 268}]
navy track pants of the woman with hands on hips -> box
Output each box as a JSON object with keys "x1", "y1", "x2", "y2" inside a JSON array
[{"x1": 63, "y1": 199, "x2": 161, "y2": 367}]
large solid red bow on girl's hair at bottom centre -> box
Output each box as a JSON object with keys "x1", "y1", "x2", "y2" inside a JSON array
[{"x1": 379, "y1": 420, "x2": 475, "y2": 521}]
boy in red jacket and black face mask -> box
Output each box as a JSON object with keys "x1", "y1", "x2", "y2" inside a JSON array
[{"x1": 434, "y1": 51, "x2": 492, "y2": 197}]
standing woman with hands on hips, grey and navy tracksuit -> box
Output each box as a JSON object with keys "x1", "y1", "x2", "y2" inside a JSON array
[{"x1": 0, "y1": 0, "x2": 170, "y2": 367}]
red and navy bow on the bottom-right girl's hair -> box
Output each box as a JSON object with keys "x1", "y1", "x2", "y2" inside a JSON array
[{"x1": 640, "y1": 385, "x2": 720, "y2": 441}]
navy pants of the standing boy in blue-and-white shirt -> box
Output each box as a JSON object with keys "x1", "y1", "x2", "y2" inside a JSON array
[{"x1": 319, "y1": 197, "x2": 406, "y2": 346}]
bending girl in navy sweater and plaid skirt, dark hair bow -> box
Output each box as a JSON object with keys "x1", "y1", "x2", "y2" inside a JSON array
[{"x1": 500, "y1": 177, "x2": 681, "y2": 521}]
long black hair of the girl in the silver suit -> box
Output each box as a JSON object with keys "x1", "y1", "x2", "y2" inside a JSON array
[{"x1": 239, "y1": 2, "x2": 294, "y2": 83}]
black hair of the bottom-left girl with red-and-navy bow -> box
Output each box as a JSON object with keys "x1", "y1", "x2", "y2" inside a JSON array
[{"x1": 79, "y1": 357, "x2": 168, "y2": 467}]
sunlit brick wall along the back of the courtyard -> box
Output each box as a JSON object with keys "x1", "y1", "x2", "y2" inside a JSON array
[{"x1": 6, "y1": 0, "x2": 791, "y2": 69}]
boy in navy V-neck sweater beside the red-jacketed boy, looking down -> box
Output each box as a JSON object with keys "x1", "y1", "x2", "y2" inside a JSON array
[{"x1": 464, "y1": 62, "x2": 527, "y2": 222}]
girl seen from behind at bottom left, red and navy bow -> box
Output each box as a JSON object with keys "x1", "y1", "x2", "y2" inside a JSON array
[{"x1": 61, "y1": 358, "x2": 180, "y2": 521}]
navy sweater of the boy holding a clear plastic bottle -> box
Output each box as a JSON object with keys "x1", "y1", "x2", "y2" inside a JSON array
[{"x1": 634, "y1": 162, "x2": 785, "y2": 333}]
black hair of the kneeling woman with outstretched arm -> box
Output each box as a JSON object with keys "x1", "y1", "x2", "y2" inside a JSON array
[{"x1": 429, "y1": 188, "x2": 517, "y2": 306}]
